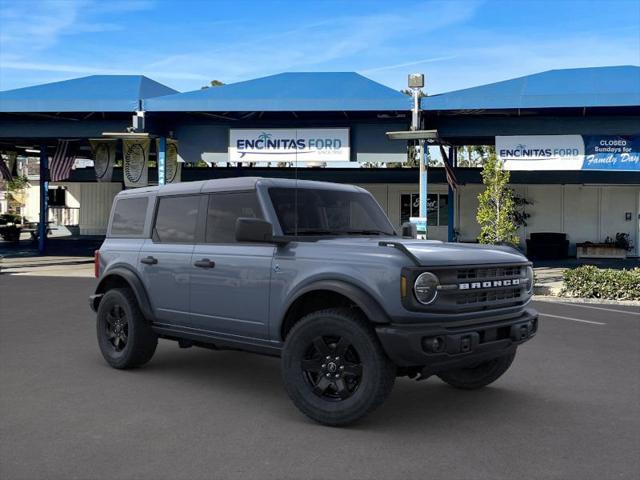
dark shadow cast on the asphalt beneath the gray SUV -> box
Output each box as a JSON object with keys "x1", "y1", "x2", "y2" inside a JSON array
[{"x1": 116, "y1": 342, "x2": 556, "y2": 433}]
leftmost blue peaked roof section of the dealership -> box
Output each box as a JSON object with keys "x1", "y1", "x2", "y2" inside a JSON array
[{"x1": 0, "y1": 75, "x2": 177, "y2": 113}]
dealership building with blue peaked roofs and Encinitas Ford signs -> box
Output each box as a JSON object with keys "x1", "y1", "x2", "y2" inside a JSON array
[{"x1": 0, "y1": 66, "x2": 640, "y2": 256}]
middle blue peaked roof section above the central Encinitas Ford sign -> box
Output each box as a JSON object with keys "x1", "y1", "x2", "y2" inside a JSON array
[{"x1": 144, "y1": 72, "x2": 411, "y2": 112}]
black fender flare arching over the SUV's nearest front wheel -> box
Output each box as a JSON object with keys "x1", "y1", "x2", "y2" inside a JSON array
[{"x1": 281, "y1": 280, "x2": 391, "y2": 324}]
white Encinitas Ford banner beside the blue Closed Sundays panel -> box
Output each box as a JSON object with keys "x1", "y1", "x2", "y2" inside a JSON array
[{"x1": 496, "y1": 135, "x2": 584, "y2": 170}]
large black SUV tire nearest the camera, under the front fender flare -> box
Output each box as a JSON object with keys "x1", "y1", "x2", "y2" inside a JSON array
[{"x1": 282, "y1": 308, "x2": 396, "y2": 426}]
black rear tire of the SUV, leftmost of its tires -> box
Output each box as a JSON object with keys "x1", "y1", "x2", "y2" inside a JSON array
[{"x1": 96, "y1": 288, "x2": 158, "y2": 369}]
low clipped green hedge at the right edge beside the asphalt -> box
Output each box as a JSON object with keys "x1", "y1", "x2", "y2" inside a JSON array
[{"x1": 560, "y1": 265, "x2": 640, "y2": 300}]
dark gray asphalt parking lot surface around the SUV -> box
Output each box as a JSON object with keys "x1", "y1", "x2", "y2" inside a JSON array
[{"x1": 0, "y1": 274, "x2": 640, "y2": 480}]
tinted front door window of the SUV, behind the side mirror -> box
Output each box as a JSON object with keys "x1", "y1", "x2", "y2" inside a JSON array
[{"x1": 206, "y1": 192, "x2": 262, "y2": 243}]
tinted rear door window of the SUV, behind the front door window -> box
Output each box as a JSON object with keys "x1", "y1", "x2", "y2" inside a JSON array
[{"x1": 153, "y1": 195, "x2": 200, "y2": 243}]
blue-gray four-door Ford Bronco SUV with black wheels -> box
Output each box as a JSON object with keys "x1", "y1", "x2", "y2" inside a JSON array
[{"x1": 90, "y1": 178, "x2": 537, "y2": 425}]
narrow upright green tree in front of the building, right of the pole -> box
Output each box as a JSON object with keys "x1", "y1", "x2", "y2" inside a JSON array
[{"x1": 476, "y1": 154, "x2": 520, "y2": 246}]
